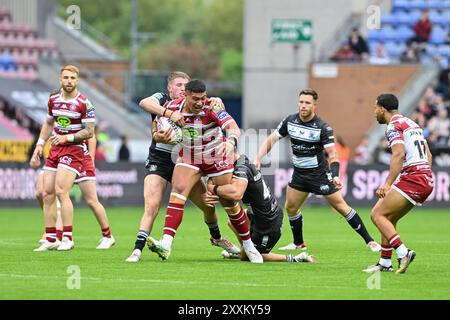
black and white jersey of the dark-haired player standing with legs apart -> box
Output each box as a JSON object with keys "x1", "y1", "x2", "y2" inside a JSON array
[{"x1": 276, "y1": 113, "x2": 334, "y2": 171}]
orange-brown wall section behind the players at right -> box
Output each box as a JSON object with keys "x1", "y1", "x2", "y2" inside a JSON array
[{"x1": 309, "y1": 64, "x2": 419, "y2": 155}]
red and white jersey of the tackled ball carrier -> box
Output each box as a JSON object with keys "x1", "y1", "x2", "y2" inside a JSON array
[{"x1": 165, "y1": 98, "x2": 236, "y2": 155}]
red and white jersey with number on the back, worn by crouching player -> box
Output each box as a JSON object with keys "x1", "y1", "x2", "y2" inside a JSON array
[{"x1": 386, "y1": 114, "x2": 431, "y2": 173}]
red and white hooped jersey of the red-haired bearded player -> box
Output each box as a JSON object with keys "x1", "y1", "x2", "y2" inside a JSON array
[{"x1": 47, "y1": 93, "x2": 95, "y2": 145}]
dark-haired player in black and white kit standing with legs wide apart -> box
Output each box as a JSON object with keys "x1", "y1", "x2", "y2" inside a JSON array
[{"x1": 255, "y1": 89, "x2": 381, "y2": 251}]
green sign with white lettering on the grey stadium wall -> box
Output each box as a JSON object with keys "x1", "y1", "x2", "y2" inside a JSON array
[{"x1": 272, "y1": 19, "x2": 313, "y2": 43}]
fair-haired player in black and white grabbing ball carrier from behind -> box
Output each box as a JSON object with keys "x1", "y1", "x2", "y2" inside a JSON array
[{"x1": 126, "y1": 71, "x2": 239, "y2": 262}]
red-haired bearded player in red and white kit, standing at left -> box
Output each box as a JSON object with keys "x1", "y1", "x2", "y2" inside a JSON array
[{"x1": 32, "y1": 65, "x2": 95, "y2": 251}]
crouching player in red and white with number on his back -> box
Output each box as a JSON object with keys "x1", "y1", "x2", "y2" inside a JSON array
[{"x1": 364, "y1": 93, "x2": 434, "y2": 273}]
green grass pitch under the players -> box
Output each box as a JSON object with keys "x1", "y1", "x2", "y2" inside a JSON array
[{"x1": 0, "y1": 207, "x2": 450, "y2": 300}]
